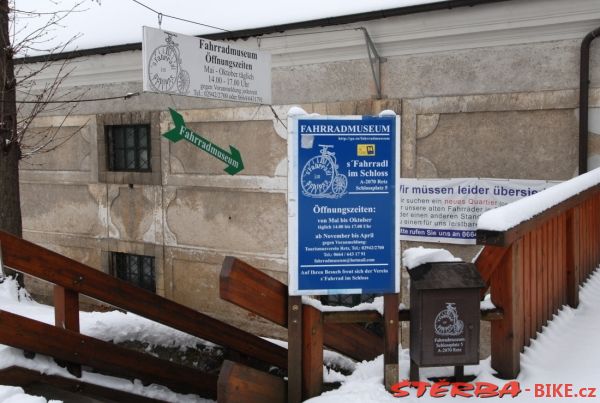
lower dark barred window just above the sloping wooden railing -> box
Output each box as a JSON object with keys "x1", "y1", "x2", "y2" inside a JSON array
[{"x1": 110, "y1": 252, "x2": 156, "y2": 292}]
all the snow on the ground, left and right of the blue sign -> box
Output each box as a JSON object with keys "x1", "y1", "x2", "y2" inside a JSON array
[{"x1": 0, "y1": 271, "x2": 600, "y2": 403}]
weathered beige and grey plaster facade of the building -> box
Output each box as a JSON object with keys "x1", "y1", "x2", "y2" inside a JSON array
[{"x1": 15, "y1": 0, "x2": 600, "y2": 344}]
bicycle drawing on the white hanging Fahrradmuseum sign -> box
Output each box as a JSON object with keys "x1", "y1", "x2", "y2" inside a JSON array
[{"x1": 148, "y1": 32, "x2": 190, "y2": 95}]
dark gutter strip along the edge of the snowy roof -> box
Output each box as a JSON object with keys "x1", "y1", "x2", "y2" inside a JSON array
[{"x1": 14, "y1": 0, "x2": 510, "y2": 64}]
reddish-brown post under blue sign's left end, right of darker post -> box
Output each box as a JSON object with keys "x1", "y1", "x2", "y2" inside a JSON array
[{"x1": 302, "y1": 305, "x2": 323, "y2": 400}]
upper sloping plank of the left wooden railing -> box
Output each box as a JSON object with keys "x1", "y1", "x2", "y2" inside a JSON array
[{"x1": 0, "y1": 231, "x2": 287, "y2": 369}]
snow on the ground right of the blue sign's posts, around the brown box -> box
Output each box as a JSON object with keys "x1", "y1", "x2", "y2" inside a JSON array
[{"x1": 309, "y1": 271, "x2": 600, "y2": 403}]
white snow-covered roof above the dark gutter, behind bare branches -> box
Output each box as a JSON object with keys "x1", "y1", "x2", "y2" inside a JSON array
[{"x1": 14, "y1": 0, "x2": 441, "y2": 56}]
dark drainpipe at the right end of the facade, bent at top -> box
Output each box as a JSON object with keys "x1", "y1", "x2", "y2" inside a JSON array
[{"x1": 579, "y1": 28, "x2": 600, "y2": 175}]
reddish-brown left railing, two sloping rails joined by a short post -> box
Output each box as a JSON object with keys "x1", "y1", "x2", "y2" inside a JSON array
[{"x1": 0, "y1": 231, "x2": 287, "y2": 397}]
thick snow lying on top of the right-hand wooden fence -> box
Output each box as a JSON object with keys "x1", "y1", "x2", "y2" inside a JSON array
[{"x1": 477, "y1": 168, "x2": 600, "y2": 231}]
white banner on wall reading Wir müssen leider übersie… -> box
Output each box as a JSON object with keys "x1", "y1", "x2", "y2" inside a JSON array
[{"x1": 400, "y1": 178, "x2": 560, "y2": 244}]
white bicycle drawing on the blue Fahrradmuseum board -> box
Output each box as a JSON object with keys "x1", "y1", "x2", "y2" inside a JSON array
[{"x1": 300, "y1": 144, "x2": 348, "y2": 199}]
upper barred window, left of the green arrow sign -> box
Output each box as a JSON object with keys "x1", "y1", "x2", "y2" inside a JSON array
[{"x1": 105, "y1": 125, "x2": 151, "y2": 172}]
